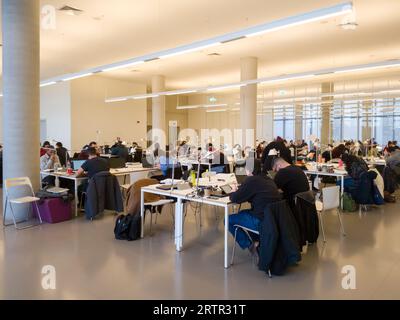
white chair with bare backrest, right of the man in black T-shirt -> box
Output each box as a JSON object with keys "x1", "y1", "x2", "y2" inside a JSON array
[{"x1": 315, "y1": 186, "x2": 346, "y2": 242}]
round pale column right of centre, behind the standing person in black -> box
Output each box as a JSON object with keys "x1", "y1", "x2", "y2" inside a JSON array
[{"x1": 240, "y1": 57, "x2": 257, "y2": 146}]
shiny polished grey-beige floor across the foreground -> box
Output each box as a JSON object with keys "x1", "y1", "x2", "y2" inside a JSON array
[{"x1": 0, "y1": 189, "x2": 400, "y2": 299}]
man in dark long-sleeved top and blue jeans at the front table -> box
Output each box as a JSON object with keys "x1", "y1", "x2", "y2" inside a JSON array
[{"x1": 229, "y1": 158, "x2": 281, "y2": 254}]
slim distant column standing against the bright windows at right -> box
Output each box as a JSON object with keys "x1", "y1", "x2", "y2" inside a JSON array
[{"x1": 320, "y1": 82, "x2": 334, "y2": 146}]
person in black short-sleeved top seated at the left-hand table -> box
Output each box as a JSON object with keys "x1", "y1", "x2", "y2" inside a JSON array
[{"x1": 76, "y1": 147, "x2": 110, "y2": 198}]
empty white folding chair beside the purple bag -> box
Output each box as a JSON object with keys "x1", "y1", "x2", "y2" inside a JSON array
[{"x1": 3, "y1": 177, "x2": 42, "y2": 230}]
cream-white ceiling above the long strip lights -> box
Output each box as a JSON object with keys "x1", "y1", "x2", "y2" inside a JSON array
[{"x1": 2, "y1": 0, "x2": 400, "y2": 89}]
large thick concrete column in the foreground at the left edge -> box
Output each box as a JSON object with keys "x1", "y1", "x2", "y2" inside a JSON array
[{"x1": 2, "y1": 0, "x2": 40, "y2": 218}]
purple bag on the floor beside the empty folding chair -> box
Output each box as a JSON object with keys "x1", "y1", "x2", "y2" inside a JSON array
[{"x1": 32, "y1": 198, "x2": 72, "y2": 223}]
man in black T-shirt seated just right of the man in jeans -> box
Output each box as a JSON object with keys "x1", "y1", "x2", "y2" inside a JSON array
[{"x1": 272, "y1": 158, "x2": 310, "y2": 206}]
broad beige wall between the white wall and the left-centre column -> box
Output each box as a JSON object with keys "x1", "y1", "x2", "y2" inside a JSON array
[{"x1": 71, "y1": 76, "x2": 147, "y2": 150}]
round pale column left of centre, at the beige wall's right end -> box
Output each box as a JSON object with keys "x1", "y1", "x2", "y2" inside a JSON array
[{"x1": 151, "y1": 75, "x2": 167, "y2": 150}]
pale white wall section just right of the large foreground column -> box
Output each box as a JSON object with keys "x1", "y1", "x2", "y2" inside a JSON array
[{"x1": 40, "y1": 82, "x2": 71, "y2": 149}]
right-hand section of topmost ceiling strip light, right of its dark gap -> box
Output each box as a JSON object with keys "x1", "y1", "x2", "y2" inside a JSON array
[{"x1": 246, "y1": 2, "x2": 353, "y2": 37}]
